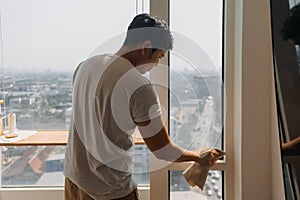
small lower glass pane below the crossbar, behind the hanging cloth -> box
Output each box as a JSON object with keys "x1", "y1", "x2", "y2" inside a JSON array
[{"x1": 170, "y1": 171, "x2": 223, "y2": 200}]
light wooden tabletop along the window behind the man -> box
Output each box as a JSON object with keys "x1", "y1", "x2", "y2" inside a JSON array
[{"x1": 0, "y1": 130, "x2": 144, "y2": 146}]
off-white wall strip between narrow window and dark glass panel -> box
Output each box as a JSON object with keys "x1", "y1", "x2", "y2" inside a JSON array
[{"x1": 233, "y1": 0, "x2": 284, "y2": 200}]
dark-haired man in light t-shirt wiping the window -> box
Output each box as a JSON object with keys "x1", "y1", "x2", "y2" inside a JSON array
[{"x1": 64, "y1": 14, "x2": 218, "y2": 200}]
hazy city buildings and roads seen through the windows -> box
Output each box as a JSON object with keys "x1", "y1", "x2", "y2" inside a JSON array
[{"x1": 1, "y1": 70, "x2": 223, "y2": 199}]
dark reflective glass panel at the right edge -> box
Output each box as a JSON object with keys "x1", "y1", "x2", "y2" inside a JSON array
[{"x1": 271, "y1": 0, "x2": 300, "y2": 200}]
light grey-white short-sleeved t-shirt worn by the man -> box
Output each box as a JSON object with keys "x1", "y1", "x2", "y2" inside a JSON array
[{"x1": 64, "y1": 55, "x2": 161, "y2": 200}]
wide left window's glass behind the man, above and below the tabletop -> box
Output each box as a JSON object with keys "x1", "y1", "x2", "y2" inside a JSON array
[{"x1": 0, "y1": 0, "x2": 149, "y2": 187}]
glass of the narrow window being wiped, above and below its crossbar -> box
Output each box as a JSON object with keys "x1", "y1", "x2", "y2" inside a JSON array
[{"x1": 169, "y1": 0, "x2": 225, "y2": 200}]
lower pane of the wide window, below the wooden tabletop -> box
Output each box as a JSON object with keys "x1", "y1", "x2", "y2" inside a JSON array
[{"x1": 0, "y1": 145, "x2": 150, "y2": 187}]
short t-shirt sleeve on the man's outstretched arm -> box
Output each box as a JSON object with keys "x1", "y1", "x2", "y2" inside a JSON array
[{"x1": 130, "y1": 83, "x2": 161, "y2": 122}]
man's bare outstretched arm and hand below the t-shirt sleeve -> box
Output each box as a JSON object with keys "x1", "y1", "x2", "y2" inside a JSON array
[{"x1": 136, "y1": 117, "x2": 214, "y2": 165}]
